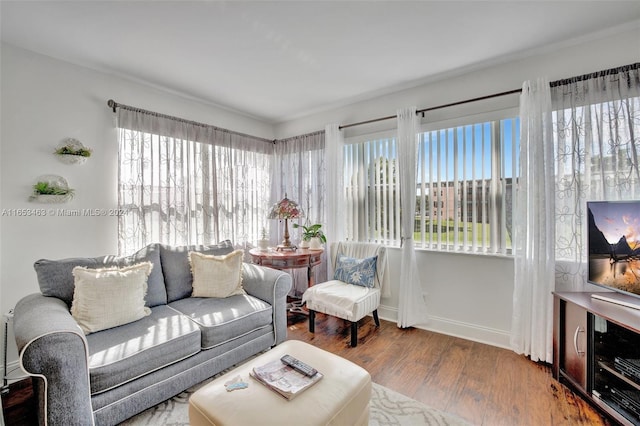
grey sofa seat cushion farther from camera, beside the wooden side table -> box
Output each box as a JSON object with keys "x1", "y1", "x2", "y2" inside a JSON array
[{"x1": 169, "y1": 294, "x2": 273, "y2": 349}]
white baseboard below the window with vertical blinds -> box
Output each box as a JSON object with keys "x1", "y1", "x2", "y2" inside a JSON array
[{"x1": 378, "y1": 305, "x2": 511, "y2": 349}]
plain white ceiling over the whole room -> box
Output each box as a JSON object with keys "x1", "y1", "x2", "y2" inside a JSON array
[{"x1": 0, "y1": 0, "x2": 640, "y2": 123}]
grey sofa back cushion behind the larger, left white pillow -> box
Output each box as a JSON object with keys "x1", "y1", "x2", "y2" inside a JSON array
[{"x1": 33, "y1": 244, "x2": 167, "y2": 307}]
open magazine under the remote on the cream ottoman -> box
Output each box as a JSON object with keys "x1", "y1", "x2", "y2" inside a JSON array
[{"x1": 249, "y1": 359, "x2": 323, "y2": 400}]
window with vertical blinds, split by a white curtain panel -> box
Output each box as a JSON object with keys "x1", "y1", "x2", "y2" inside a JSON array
[{"x1": 344, "y1": 118, "x2": 519, "y2": 254}]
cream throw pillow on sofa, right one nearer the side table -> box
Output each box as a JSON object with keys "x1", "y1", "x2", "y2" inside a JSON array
[{"x1": 189, "y1": 250, "x2": 246, "y2": 298}]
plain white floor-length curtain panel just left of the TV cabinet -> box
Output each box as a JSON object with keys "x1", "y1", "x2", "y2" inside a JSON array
[{"x1": 511, "y1": 79, "x2": 555, "y2": 362}]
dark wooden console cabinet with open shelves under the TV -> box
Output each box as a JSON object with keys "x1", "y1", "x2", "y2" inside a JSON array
[{"x1": 552, "y1": 292, "x2": 640, "y2": 425}]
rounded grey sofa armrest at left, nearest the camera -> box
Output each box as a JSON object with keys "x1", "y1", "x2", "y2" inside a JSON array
[{"x1": 13, "y1": 294, "x2": 93, "y2": 425}]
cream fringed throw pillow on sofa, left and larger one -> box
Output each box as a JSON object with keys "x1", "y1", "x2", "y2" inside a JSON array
[{"x1": 71, "y1": 262, "x2": 153, "y2": 334}]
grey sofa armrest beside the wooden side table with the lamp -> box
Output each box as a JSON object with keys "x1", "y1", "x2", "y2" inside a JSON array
[{"x1": 242, "y1": 263, "x2": 292, "y2": 346}]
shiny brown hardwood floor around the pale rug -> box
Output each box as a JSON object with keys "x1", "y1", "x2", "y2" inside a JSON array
[{"x1": 2, "y1": 314, "x2": 612, "y2": 426}]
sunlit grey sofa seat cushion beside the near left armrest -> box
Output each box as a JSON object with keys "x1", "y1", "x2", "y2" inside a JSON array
[{"x1": 87, "y1": 305, "x2": 201, "y2": 395}]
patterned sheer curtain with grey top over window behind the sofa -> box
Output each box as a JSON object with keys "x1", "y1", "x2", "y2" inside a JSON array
[{"x1": 116, "y1": 106, "x2": 273, "y2": 254}]
